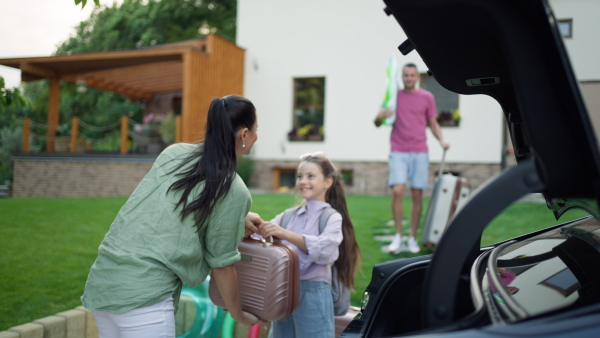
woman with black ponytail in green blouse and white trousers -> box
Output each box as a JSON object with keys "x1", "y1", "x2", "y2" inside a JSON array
[{"x1": 81, "y1": 95, "x2": 262, "y2": 338}]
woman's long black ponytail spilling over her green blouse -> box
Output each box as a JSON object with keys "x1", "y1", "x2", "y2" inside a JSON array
[{"x1": 167, "y1": 95, "x2": 256, "y2": 231}]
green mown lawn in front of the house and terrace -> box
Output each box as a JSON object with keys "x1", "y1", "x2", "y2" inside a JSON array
[{"x1": 0, "y1": 194, "x2": 583, "y2": 331}]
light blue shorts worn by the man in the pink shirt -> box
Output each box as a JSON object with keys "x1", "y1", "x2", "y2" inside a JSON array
[{"x1": 389, "y1": 151, "x2": 429, "y2": 189}]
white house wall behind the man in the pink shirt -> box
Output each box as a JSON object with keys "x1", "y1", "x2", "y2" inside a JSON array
[{"x1": 237, "y1": 0, "x2": 503, "y2": 163}]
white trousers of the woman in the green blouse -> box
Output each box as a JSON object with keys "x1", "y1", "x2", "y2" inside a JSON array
[{"x1": 92, "y1": 297, "x2": 175, "y2": 338}]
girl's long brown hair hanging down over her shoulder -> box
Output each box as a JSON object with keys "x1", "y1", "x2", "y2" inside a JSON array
[{"x1": 302, "y1": 154, "x2": 361, "y2": 290}]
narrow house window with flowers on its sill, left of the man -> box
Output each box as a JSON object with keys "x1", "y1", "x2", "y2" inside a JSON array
[{"x1": 288, "y1": 77, "x2": 325, "y2": 141}]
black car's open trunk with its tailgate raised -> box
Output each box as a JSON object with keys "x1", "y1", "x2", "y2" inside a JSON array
[{"x1": 347, "y1": 0, "x2": 600, "y2": 337}]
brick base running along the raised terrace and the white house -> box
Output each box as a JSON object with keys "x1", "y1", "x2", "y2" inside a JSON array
[{"x1": 12, "y1": 155, "x2": 514, "y2": 197}]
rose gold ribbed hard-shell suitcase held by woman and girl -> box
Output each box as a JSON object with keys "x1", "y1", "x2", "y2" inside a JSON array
[{"x1": 209, "y1": 238, "x2": 300, "y2": 321}]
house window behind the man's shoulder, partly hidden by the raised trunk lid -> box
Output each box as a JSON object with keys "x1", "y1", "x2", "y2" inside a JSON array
[{"x1": 421, "y1": 74, "x2": 461, "y2": 126}]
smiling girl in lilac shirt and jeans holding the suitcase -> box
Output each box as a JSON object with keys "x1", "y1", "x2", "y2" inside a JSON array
[{"x1": 259, "y1": 152, "x2": 360, "y2": 338}]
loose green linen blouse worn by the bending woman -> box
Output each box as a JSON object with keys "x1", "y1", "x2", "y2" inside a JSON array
[{"x1": 81, "y1": 143, "x2": 252, "y2": 313}]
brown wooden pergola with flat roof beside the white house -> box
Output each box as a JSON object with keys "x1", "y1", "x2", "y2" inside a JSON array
[{"x1": 0, "y1": 34, "x2": 245, "y2": 152}]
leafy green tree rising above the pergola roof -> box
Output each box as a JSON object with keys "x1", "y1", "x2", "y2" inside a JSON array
[{"x1": 57, "y1": 0, "x2": 237, "y2": 54}]
